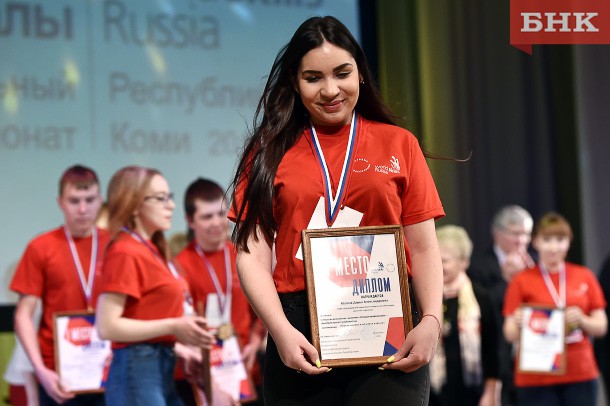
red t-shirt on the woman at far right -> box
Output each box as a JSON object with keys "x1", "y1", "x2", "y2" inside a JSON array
[{"x1": 503, "y1": 262, "x2": 606, "y2": 386}]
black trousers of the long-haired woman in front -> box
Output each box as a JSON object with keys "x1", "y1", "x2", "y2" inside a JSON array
[{"x1": 264, "y1": 292, "x2": 430, "y2": 406}]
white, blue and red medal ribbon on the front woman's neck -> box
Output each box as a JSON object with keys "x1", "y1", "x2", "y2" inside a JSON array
[{"x1": 310, "y1": 112, "x2": 357, "y2": 227}]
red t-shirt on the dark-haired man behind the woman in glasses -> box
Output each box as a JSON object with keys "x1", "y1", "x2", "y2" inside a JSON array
[{"x1": 176, "y1": 241, "x2": 256, "y2": 345}]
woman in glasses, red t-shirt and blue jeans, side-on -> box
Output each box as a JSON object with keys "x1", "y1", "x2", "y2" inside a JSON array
[{"x1": 96, "y1": 166, "x2": 213, "y2": 406}]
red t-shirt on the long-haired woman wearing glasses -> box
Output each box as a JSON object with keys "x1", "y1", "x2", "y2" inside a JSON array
[{"x1": 98, "y1": 232, "x2": 186, "y2": 348}]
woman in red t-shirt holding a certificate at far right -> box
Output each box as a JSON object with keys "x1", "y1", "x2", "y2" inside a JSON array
[{"x1": 504, "y1": 213, "x2": 608, "y2": 406}]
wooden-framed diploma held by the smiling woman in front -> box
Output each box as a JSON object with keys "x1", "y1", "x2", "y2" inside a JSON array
[{"x1": 302, "y1": 225, "x2": 413, "y2": 367}]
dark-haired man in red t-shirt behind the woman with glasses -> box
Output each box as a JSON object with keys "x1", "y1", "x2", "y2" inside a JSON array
[{"x1": 176, "y1": 178, "x2": 265, "y2": 406}]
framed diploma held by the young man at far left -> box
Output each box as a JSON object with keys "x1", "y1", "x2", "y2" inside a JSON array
[{"x1": 53, "y1": 311, "x2": 112, "y2": 393}]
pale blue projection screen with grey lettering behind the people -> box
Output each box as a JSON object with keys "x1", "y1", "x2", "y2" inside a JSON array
[{"x1": 0, "y1": 0, "x2": 359, "y2": 303}]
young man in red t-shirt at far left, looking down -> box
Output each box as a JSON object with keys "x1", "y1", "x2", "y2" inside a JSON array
[{"x1": 10, "y1": 165, "x2": 109, "y2": 405}]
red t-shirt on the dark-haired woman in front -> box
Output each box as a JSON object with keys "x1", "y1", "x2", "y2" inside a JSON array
[{"x1": 229, "y1": 116, "x2": 445, "y2": 292}]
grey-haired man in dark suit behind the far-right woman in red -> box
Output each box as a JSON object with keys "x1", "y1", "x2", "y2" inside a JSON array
[{"x1": 468, "y1": 205, "x2": 534, "y2": 406}]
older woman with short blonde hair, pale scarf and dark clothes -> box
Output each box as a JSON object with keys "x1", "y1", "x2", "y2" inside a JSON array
[{"x1": 430, "y1": 225, "x2": 499, "y2": 406}]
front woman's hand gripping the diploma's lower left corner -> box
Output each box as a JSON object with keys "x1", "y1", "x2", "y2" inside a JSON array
[{"x1": 273, "y1": 325, "x2": 330, "y2": 375}]
